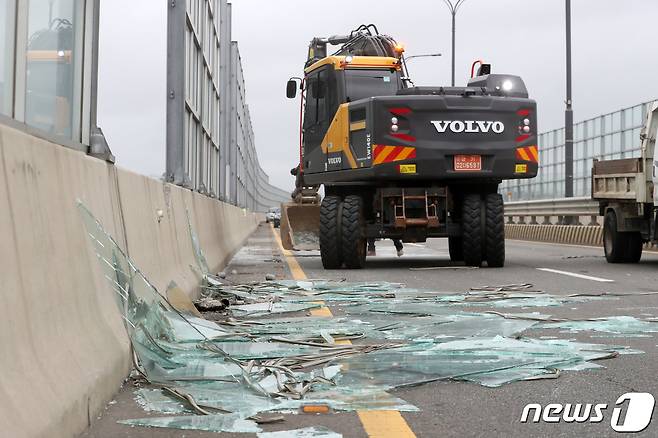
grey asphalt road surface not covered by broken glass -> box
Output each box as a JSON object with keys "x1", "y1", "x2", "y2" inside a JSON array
[{"x1": 83, "y1": 226, "x2": 658, "y2": 437}]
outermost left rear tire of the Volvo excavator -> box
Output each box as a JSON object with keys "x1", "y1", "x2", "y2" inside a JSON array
[{"x1": 320, "y1": 196, "x2": 343, "y2": 269}]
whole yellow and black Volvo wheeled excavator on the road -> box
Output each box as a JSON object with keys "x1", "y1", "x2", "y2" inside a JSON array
[{"x1": 281, "y1": 25, "x2": 539, "y2": 269}]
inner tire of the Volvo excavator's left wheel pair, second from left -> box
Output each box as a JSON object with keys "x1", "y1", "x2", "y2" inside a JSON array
[{"x1": 341, "y1": 195, "x2": 367, "y2": 269}]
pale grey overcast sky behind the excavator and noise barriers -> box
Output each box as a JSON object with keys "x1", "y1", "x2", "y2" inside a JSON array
[{"x1": 99, "y1": 0, "x2": 658, "y2": 190}]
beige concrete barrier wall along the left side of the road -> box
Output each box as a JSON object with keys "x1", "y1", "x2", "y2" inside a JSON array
[{"x1": 0, "y1": 125, "x2": 261, "y2": 437}]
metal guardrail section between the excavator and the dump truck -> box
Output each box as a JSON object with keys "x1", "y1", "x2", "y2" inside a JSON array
[{"x1": 505, "y1": 197, "x2": 600, "y2": 225}]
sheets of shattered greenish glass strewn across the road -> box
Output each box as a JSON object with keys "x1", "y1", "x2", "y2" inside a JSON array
[{"x1": 79, "y1": 204, "x2": 658, "y2": 437}]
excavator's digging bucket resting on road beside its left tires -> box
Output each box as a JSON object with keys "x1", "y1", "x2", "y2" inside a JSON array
[{"x1": 281, "y1": 202, "x2": 320, "y2": 251}]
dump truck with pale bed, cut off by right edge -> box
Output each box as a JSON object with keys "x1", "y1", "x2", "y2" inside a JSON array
[{"x1": 592, "y1": 102, "x2": 658, "y2": 263}]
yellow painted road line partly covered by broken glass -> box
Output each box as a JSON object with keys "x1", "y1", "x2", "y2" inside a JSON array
[{"x1": 271, "y1": 226, "x2": 416, "y2": 438}]
